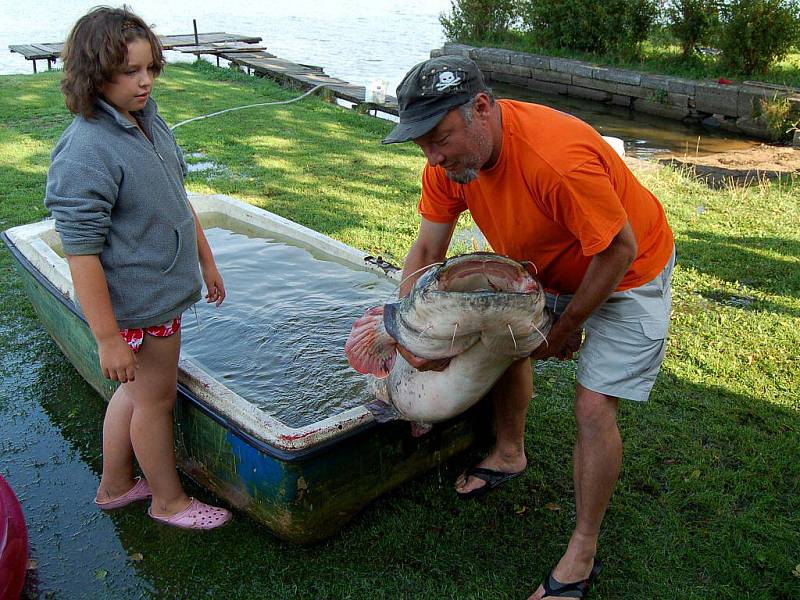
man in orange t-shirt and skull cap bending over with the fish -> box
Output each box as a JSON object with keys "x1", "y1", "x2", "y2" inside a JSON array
[{"x1": 383, "y1": 56, "x2": 674, "y2": 600}]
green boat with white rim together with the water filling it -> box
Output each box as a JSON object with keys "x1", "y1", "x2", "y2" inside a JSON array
[{"x1": 3, "y1": 195, "x2": 482, "y2": 543}]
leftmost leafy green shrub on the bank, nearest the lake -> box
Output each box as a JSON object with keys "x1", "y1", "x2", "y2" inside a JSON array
[{"x1": 439, "y1": 0, "x2": 515, "y2": 42}]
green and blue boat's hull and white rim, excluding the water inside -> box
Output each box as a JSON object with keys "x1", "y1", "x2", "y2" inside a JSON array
[{"x1": 3, "y1": 195, "x2": 486, "y2": 544}]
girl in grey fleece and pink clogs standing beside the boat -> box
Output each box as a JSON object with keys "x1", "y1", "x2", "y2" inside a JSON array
[{"x1": 45, "y1": 7, "x2": 231, "y2": 529}]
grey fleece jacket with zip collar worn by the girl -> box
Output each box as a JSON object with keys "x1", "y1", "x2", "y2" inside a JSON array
[{"x1": 45, "y1": 99, "x2": 202, "y2": 328}]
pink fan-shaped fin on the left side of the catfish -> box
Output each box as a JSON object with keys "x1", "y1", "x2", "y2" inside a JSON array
[{"x1": 344, "y1": 306, "x2": 397, "y2": 378}]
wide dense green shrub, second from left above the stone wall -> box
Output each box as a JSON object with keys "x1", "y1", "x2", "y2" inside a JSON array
[{"x1": 521, "y1": 0, "x2": 658, "y2": 56}]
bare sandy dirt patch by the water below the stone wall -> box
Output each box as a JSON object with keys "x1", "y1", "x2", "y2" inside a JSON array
[{"x1": 658, "y1": 144, "x2": 800, "y2": 187}]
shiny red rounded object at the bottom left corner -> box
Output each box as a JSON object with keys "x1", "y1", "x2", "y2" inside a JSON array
[{"x1": 0, "y1": 476, "x2": 28, "y2": 600}]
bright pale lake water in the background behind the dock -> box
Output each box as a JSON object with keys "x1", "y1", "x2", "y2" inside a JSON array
[{"x1": 0, "y1": 0, "x2": 450, "y2": 90}]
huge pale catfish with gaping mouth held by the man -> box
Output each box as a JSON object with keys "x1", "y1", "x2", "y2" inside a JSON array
[{"x1": 345, "y1": 253, "x2": 553, "y2": 424}]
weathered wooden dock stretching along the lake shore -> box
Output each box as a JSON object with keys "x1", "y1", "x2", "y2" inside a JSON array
[{"x1": 9, "y1": 32, "x2": 397, "y2": 115}]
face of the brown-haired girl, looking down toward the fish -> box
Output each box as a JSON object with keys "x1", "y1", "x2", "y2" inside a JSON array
[{"x1": 101, "y1": 38, "x2": 155, "y2": 121}]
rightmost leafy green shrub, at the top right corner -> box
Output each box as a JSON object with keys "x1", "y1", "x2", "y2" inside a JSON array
[{"x1": 719, "y1": 0, "x2": 800, "y2": 73}]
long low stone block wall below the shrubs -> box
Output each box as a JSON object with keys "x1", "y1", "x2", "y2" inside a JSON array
[{"x1": 431, "y1": 42, "x2": 800, "y2": 140}]
